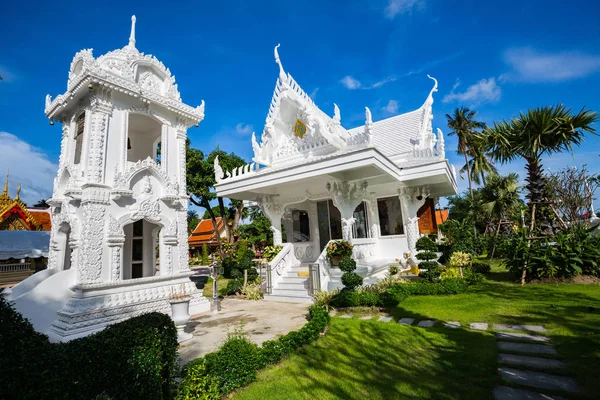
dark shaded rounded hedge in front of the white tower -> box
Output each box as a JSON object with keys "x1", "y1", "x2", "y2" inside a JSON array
[{"x1": 0, "y1": 296, "x2": 178, "y2": 400}]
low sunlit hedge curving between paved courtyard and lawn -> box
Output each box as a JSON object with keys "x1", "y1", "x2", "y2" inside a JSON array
[{"x1": 176, "y1": 306, "x2": 329, "y2": 400}]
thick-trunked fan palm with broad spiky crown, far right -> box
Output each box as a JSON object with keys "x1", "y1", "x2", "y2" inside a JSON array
[{"x1": 485, "y1": 104, "x2": 598, "y2": 235}]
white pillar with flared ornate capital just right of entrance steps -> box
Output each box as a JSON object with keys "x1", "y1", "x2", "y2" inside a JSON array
[{"x1": 326, "y1": 181, "x2": 368, "y2": 241}]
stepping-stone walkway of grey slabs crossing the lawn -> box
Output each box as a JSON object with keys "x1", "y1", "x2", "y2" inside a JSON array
[{"x1": 342, "y1": 315, "x2": 580, "y2": 400}]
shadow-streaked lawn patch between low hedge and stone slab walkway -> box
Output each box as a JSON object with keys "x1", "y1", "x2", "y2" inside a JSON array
[{"x1": 239, "y1": 308, "x2": 498, "y2": 399}]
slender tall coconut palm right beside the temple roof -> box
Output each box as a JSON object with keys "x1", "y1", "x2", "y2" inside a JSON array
[{"x1": 446, "y1": 107, "x2": 485, "y2": 197}]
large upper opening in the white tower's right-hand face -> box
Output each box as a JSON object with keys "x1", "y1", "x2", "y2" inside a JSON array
[{"x1": 127, "y1": 114, "x2": 162, "y2": 164}]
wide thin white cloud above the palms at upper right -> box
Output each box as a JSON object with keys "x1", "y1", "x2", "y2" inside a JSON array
[{"x1": 502, "y1": 47, "x2": 600, "y2": 82}]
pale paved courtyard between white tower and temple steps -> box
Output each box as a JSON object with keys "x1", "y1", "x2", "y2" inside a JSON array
[{"x1": 179, "y1": 298, "x2": 309, "y2": 364}]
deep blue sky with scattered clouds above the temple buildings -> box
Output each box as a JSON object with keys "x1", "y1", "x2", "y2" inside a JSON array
[{"x1": 0, "y1": 0, "x2": 600, "y2": 206}]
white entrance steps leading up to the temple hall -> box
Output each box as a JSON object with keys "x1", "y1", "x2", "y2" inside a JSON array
[{"x1": 265, "y1": 264, "x2": 312, "y2": 303}]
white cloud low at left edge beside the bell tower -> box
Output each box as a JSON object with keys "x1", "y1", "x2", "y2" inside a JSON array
[{"x1": 0, "y1": 132, "x2": 58, "y2": 205}]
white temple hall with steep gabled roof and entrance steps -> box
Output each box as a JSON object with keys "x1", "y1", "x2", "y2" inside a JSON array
[{"x1": 215, "y1": 45, "x2": 457, "y2": 301}]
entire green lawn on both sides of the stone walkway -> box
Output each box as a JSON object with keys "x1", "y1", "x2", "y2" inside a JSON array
[{"x1": 236, "y1": 266, "x2": 600, "y2": 399}]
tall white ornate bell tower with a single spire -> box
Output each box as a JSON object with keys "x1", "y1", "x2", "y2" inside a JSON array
[{"x1": 8, "y1": 17, "x2": 209, "y2": 341}]
